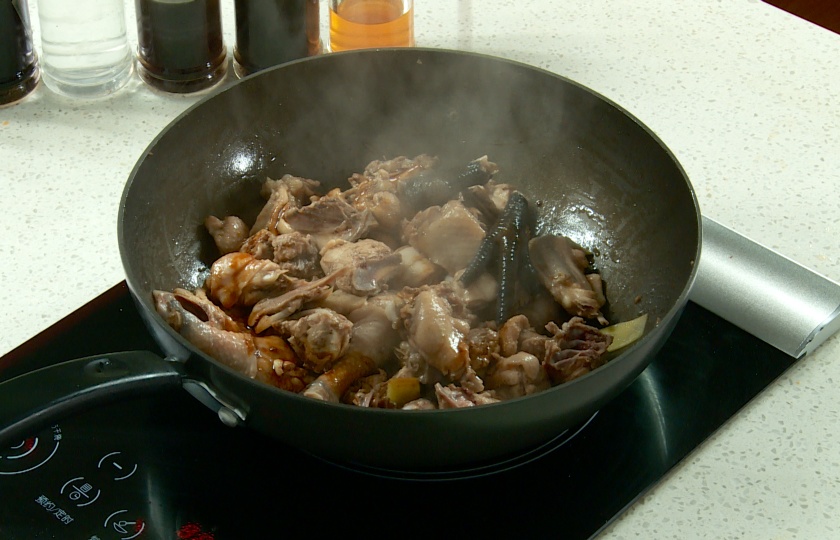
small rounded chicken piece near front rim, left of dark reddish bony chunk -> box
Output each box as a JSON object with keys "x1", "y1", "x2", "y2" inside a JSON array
[{"x1": 484, "y1": 352, "x2": 551, "y2": 400}]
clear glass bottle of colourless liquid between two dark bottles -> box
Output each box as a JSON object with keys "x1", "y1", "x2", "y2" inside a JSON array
[{"x1": 38, "y1": 0, "x2": 134, "y2": 98}]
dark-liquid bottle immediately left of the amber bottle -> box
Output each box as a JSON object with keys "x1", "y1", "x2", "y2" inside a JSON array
[{"x1": 233, "y1": 0, "x2": 321, "y2": 77}]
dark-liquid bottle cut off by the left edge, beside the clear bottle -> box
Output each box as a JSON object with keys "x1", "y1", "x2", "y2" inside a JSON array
[{"x1": 0, "y1": 0, "x2": 40, "y2": 105}]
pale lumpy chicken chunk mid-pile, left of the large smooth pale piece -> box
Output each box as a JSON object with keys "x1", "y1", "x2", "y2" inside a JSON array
[{"x1": 321, "y1": 238, "x2": 402, "y2": 296}]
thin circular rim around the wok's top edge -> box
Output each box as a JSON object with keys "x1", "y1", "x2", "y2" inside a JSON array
[{"x1": 117, "y1": 47, "x2": 703, "y2": 418}]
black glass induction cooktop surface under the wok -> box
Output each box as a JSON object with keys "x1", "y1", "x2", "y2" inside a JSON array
[{"x1": 0, "y1": 284, "x2": 796, "y2": 540}]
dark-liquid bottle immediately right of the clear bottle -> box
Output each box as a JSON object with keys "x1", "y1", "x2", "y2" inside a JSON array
[{"x1": 136, "y1": 0, "x2": 227, "y2": 93}]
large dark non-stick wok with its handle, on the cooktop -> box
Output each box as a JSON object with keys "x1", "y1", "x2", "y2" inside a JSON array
[{"x1": 0, "y1": 49, "x2": 700, "y2": 470}]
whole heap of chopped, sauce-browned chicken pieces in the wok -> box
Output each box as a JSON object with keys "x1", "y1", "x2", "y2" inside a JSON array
[{"x1": 154, "y1": 155, "x2": 628, "y2": 410}]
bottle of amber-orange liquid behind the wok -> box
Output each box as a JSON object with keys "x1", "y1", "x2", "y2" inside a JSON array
[{"x1": 330, "y1": 0, "x2": 414, "y2": 52}]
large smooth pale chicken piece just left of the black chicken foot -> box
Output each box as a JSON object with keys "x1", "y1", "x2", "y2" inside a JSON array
[{"x1": 403, "y1": 201, "x2": 484, "y2": 275}]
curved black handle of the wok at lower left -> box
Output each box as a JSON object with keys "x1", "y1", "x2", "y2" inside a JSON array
[{"x1": 0, "y1": 351, "x2": 184, "y2": 450}]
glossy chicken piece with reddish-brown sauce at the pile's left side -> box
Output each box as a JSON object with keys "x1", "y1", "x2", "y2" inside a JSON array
[{"x1": 205, "y1": 252, "x2": 292, "y2": 308}]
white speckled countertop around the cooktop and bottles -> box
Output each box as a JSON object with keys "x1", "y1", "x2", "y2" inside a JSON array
[{"x1": 0, "y1": 0, "x2": 840, "y2": 539}]
